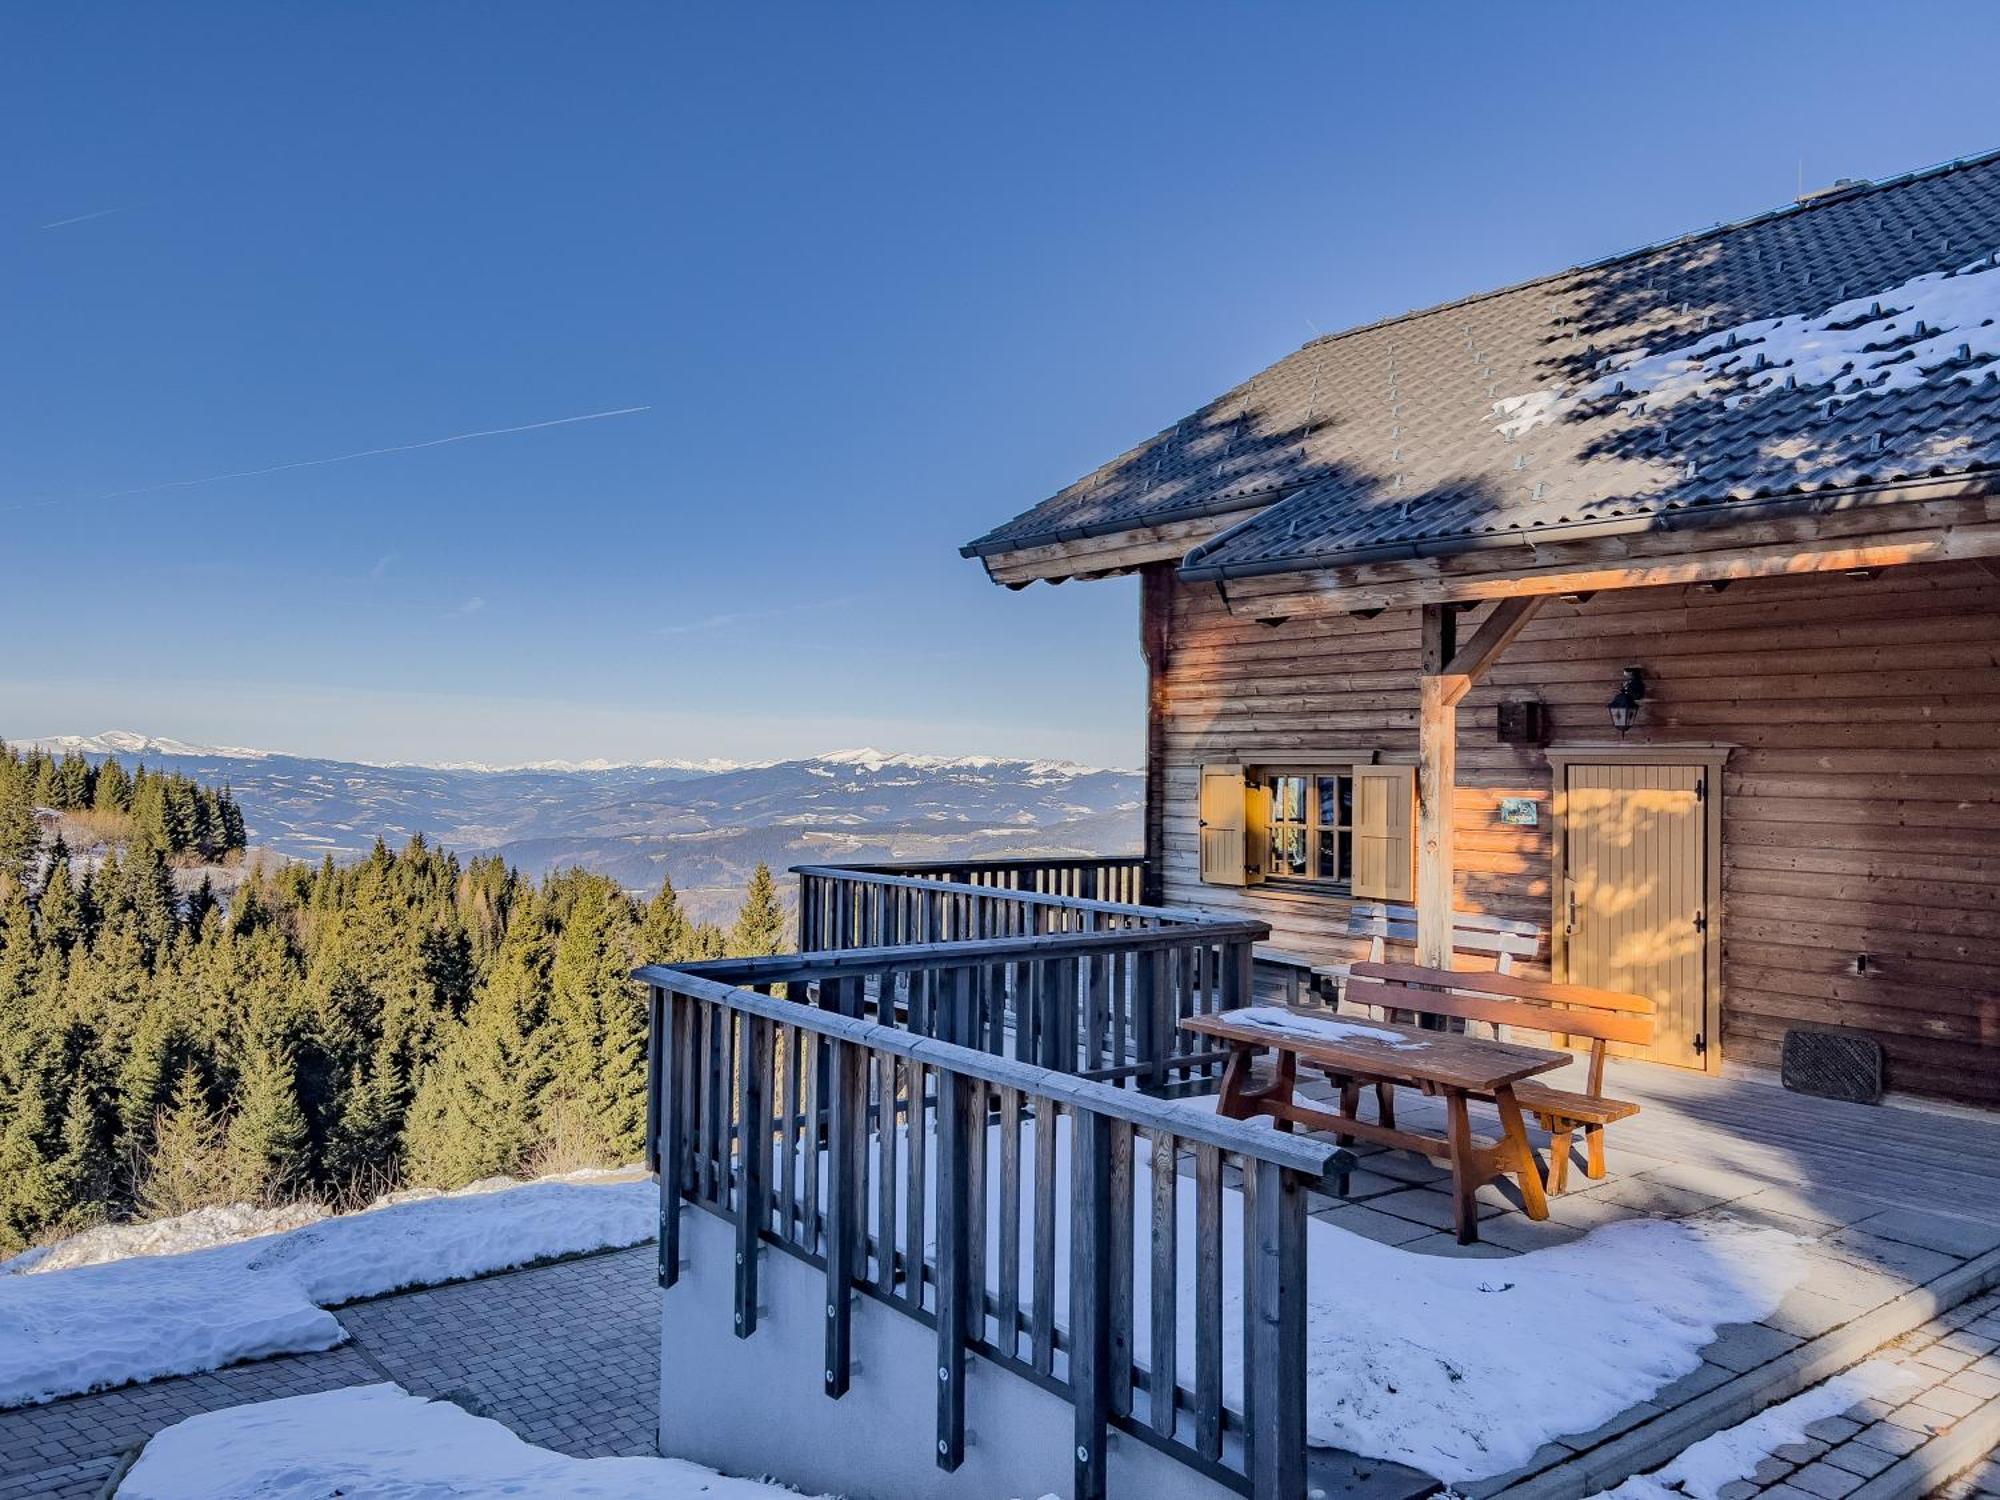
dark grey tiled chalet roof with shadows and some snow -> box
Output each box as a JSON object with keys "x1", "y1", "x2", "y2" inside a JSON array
[{"x1": 966, "y1": 152, "x2": 2000, "y2": 576}]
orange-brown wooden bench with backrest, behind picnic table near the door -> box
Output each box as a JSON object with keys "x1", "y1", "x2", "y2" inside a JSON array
[{"x1": 1342, "y1": 962, "x2": 1654, "y2": 1192}]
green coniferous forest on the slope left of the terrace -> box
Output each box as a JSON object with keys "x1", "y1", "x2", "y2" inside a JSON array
[{"x1": 0, "y1": 746, "x2": 786, "y2": 1250}]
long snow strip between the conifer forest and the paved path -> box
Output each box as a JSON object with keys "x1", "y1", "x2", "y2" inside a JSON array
[{"x1": 0, "y1": 1178, "x2": 658, "y2": 1406}]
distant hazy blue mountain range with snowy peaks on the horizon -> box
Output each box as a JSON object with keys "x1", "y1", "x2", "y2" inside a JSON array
[{"x1": 22, "y1": 730, "x2": 1142, "y2": 920}]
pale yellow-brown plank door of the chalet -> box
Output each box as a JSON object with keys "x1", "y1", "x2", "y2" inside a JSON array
[{"x1": 1562, "y1": 764, "x2": 1718, "y2": 1068}]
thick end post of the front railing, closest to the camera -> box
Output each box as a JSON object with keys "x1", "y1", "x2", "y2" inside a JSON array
[{"x1": 1244, "y1": 1162, "x2": 1306, "y2": 1500}]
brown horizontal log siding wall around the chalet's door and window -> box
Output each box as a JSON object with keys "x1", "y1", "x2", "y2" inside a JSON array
[{"x1": 1158, "y1": 564, "x2": 2000, "y2": 1104}]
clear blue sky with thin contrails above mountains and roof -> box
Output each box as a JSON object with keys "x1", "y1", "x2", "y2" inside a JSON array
[{"x1": 11, "y1": 0, "x2": 2000, "y2": 764}]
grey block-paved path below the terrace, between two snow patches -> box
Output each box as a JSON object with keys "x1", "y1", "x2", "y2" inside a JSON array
[{"x1": 0, "y1": 1244, "x2": 660, "y2": 1500}]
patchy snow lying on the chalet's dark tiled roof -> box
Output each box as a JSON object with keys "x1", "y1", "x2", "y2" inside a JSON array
[{"x1": 1492, "y1": 256, "x2": 2000, "y2": 438}]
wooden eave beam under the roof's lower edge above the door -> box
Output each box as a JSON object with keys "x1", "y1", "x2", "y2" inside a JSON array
[{"x1": 1182, "y1": 474, "x2": 2000, "y2": 620}]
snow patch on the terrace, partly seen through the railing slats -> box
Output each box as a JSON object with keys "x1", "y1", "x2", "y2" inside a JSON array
[{"x1": 836, "y1": 1102, "x2": 1806, "y2": 1482}]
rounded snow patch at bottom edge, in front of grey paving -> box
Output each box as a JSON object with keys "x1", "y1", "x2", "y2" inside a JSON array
[{"x1": 118, "y1": 1382, "x2": 820, "y2": 1500}]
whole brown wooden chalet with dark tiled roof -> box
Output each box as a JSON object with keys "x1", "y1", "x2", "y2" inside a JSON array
[{"x1": 964, "y1": 156, "x2": 2000, "y2": 1106}]
